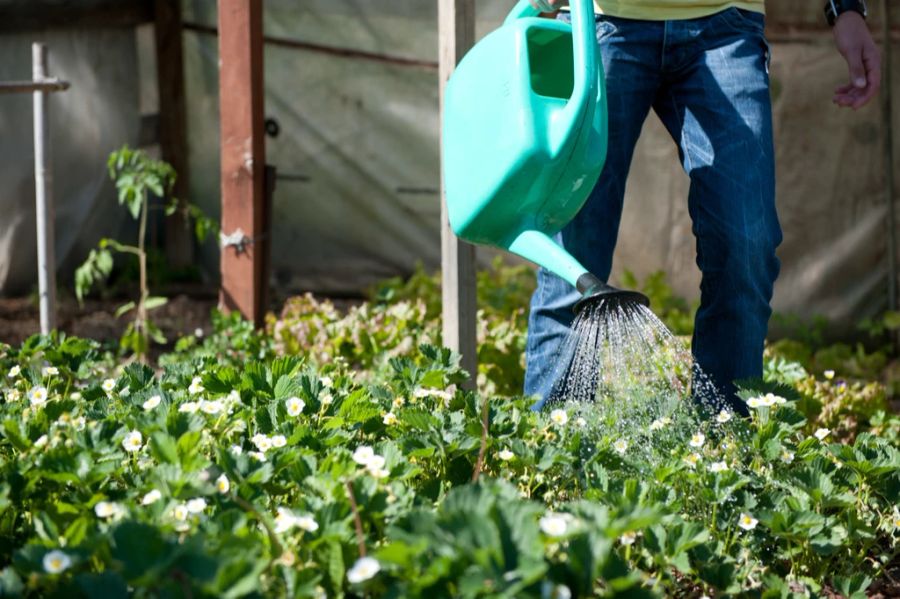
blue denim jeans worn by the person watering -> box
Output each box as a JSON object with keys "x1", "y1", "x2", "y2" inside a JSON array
[{"x1": 525, "y1": 8, "x2": 781, "y2": 413}]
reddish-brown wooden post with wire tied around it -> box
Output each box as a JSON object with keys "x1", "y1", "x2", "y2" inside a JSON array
[{"x1": 219, "y1": 0, "x2": 268, "y2": 326}]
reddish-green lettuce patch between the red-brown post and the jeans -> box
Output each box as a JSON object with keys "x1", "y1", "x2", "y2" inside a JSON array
[{"x1": 267, "y1": 257, "x2": 534, "y2": 396}]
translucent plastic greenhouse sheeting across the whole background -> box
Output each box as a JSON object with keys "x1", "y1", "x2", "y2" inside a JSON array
[{"x1": 0, "y1": 0, "x2": 900, "y2": 338}]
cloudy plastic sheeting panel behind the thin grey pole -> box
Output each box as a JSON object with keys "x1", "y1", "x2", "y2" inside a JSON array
[{"x1": 0, "y1": 29, "x2": 140, "y2": 295}]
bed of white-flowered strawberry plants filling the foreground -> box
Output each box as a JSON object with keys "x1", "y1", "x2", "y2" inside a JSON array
[{"x1": 0, "y1": 332, "x2": 900, "y2": 598}]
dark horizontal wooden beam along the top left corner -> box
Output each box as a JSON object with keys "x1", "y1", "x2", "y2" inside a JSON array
[{"x1": 0, "y1": 0, "x2": 153, "y2": 33}]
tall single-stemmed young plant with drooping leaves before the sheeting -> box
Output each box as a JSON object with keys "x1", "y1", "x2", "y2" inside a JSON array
[{"x1": 75, "y1": 145, "x2": 216, "y2": 360}]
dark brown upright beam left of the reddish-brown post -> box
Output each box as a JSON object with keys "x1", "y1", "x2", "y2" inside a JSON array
[{"x1": 153, "y1": 0, "x2": 194, "y2": 268}]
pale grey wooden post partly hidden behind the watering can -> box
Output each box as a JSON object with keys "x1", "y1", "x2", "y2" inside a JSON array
[{"x1": 438, "y1": 0, "x2": 478, "y2": 388}]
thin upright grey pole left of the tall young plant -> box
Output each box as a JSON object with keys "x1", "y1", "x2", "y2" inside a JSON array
[{"x1": 31, "y1": 43, "x2": 56, "y2": 335}]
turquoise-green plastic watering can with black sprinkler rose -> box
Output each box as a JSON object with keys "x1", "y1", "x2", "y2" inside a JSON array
[{"x1": 442, "y1": 0, "x2": 649, "y2": 312}]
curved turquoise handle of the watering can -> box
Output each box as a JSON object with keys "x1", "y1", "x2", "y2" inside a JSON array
[{"x1": 504, "y1": 0, "x2": 602, "y2": 155}]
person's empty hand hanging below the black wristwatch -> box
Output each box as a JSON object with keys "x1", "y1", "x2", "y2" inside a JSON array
[{"x1": 832, "y1": 11, "x2": 881, "y2": 110}]
